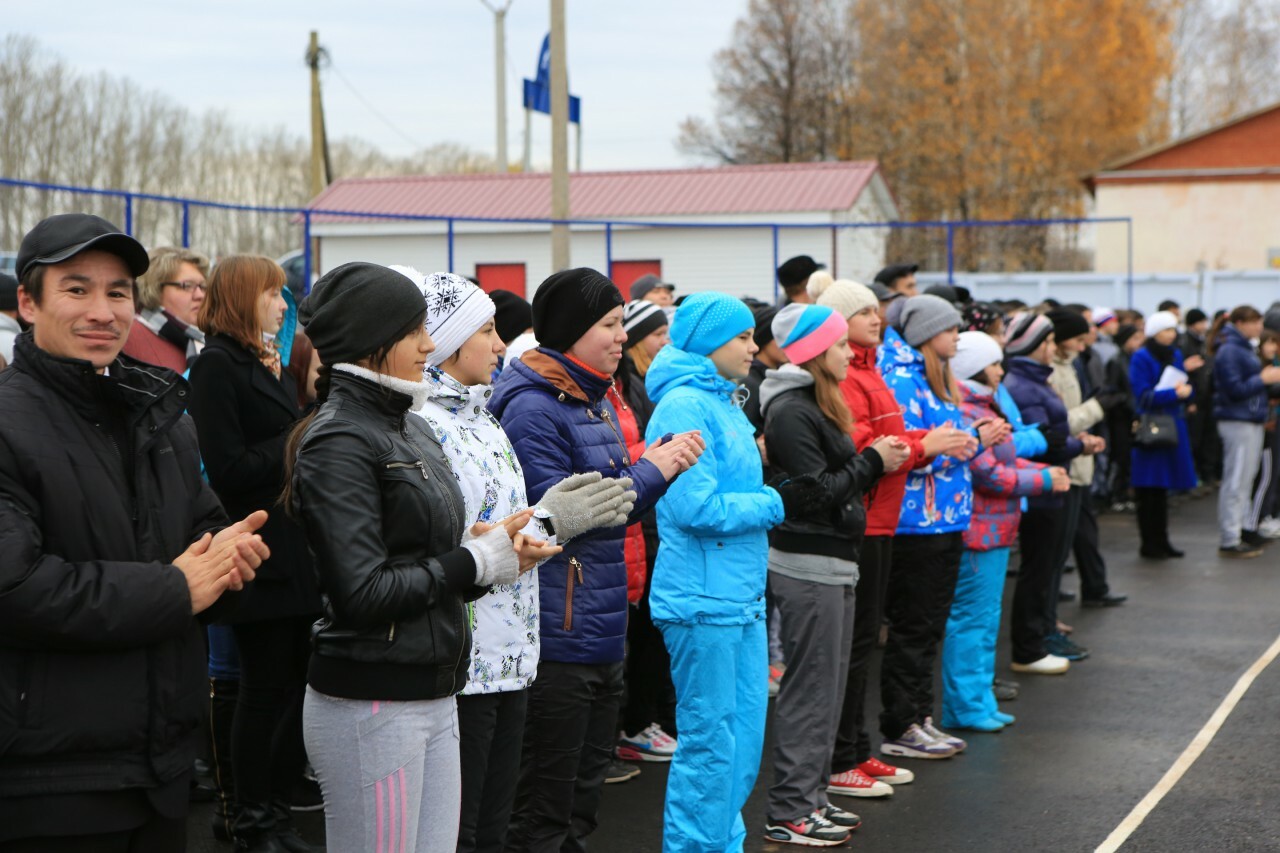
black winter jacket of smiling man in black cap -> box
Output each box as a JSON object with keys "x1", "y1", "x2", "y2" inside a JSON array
[{"x1": 0, "y1": 332, "x2": 227, "y2": 804}]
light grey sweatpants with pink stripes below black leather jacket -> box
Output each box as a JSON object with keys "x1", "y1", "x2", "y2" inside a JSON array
[{"x1": 302, "y1": 686, "x2": 462, "y2": 853}]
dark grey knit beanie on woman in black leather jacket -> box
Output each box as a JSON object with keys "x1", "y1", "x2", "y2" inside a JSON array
[{"x1": 298, "y1": 261, "x2": 426, "y2": 365}]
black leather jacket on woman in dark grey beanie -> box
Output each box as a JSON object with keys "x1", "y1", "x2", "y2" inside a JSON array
[{"x1": 291, "y1": 370, "x2": 484, "y2": 701}]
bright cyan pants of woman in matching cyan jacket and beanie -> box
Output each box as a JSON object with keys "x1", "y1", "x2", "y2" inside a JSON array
[{"x1": 658, "y1": 619, "x2": 769, "y2": 853}]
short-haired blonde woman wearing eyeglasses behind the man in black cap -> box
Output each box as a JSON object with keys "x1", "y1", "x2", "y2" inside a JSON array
[{"x1": 124, "y1": 246, "x2": 209, "y2": 374}]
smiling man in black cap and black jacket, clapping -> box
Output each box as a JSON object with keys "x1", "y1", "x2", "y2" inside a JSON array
[{"x1": 0, "y1": 214, "x2": 268, "y2": 852}]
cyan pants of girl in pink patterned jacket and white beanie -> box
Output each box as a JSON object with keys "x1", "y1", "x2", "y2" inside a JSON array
[{"x1": 942, "y1": 548, "x2": 1009, "y2": 727}]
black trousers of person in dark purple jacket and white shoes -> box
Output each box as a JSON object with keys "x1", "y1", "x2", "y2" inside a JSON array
[{"x1": 1009, "y1": 507, "x2": 1066, "y2": 663}]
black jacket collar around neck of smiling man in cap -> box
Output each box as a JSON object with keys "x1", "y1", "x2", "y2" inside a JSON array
[{"x1": 13, "y1": 330, "x2": 187, "y2": 424}]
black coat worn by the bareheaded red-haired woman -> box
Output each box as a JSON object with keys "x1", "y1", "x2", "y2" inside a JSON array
[{"x1": 189, "y1": 334, "x2": 320, "y2": 622}]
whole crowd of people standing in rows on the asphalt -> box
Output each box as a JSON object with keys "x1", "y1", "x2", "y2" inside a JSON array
[{"x1": 0, "y1": 214, "x2": 1280, "y2": 853}]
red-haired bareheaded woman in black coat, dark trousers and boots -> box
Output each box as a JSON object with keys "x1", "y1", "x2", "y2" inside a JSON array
[{"x1": 189, "y1": 255, "x2": 320, "y2": 853}]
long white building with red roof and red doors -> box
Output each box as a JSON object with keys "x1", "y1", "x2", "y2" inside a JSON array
[{"x1": 304, "y1": 161, "x2": 899, "y2": 300}]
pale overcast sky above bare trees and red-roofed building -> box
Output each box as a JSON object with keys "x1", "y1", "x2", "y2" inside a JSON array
[{"x1": 4, "y1": 0, "x2": 746, "y2": 169}]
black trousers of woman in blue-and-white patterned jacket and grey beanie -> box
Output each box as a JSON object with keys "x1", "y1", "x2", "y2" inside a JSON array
[{"x1": 880, "y1": 533, "x2": 964, "y2": 740}]
